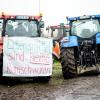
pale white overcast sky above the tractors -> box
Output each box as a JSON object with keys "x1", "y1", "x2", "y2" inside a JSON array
[{"x1": 0, "y1": 0, "x2": 100, "y2": 25}]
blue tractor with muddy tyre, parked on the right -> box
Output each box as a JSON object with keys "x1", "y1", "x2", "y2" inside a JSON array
[{"x1": 60, "y1": 15, "x2": 100, "y2": 79}]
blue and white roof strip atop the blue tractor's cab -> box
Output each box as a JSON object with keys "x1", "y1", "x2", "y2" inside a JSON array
[{"x1": 66, "y1": 15, "x2": 100, "y2": 21}]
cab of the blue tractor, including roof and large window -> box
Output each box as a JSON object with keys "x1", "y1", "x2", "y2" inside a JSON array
[{"x1": 68, "y1": 15, "x2": 100, "y2": 41}]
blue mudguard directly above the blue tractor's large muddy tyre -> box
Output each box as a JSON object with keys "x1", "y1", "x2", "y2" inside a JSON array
[{"x1": 61, "y1": 36, "x2": 78, "y2": 47}]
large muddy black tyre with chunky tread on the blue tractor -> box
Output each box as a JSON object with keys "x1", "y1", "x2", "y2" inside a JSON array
[{"x1": 60, "y1": 48, "x2": 77, "y2": 79}]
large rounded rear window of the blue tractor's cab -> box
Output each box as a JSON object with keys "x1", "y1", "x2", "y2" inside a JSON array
[{"x1": 71, "y1": 19, "x2": 100, "y2": 38}]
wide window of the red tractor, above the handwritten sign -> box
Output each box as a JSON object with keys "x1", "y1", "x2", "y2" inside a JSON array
[{"x1": 5, "y1": 19, "x2": 39, "y2": 37}]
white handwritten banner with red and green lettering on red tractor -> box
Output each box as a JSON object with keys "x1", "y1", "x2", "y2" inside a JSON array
[{"x1": 3, "y1": 37, "x2": 52, "y2": 77}]
